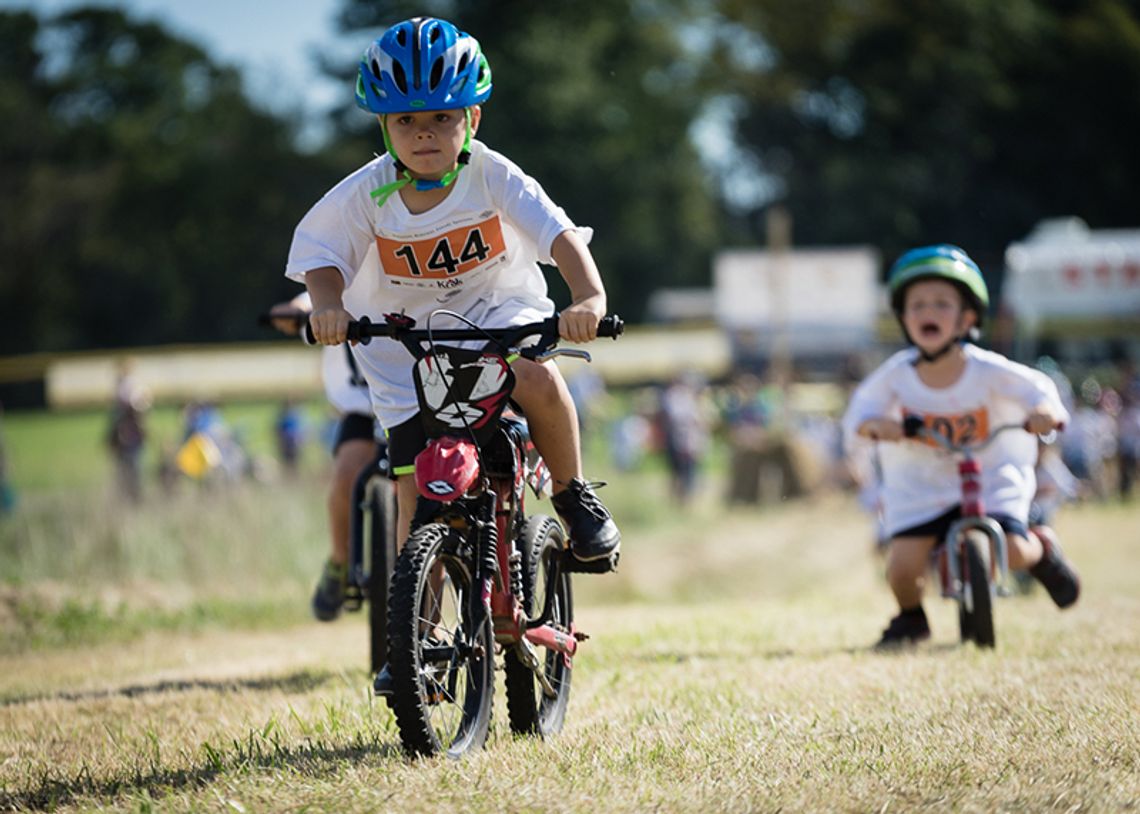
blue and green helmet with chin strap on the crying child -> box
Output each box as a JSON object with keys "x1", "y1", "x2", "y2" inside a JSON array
[{"x1": 887, "y1": 243, "x2": 990, "y2": 361}]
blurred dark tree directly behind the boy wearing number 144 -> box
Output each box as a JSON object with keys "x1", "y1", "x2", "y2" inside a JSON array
[{"x1": 323, "y1": 0, "x2": 720, "y2": 319}]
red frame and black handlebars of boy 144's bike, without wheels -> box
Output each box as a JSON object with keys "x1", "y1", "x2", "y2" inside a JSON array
[{"x1": 349, "y1": 311, "x2": 622, "y2": 670}]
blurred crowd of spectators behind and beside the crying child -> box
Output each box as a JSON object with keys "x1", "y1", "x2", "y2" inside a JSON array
[{"x1": 570, "y1": 357, "x2": 1140, "y2": 516}]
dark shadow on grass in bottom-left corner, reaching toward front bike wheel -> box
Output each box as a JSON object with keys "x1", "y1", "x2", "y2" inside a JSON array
[{"x1": 0, "y1": 736, "x2": 404, "y2": 811}]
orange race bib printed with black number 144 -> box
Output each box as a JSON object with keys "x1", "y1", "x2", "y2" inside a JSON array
[{"x1": 376, "y1": 214, "x2": 506, "y2": 287}]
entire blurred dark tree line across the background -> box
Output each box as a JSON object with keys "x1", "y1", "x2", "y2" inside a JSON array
[{"x1": 0, "y1": 0, "x2": 1140, "y2": 355}]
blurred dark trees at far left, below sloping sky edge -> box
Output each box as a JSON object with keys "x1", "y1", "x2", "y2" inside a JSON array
[{"x1": 0, "y1": 8, "x2": 336, "y2": 353}]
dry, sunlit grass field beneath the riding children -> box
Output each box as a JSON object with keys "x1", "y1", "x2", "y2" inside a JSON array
[{"x1": 0, "y1": 408, "x2": 1140, "y2": 812}]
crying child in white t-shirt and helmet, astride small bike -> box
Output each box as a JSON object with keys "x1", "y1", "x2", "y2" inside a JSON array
[{"x1": 842, "y1": 244, "x2": 1080, "y2": 648}]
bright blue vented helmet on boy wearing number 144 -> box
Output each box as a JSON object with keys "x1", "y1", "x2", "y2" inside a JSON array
[{"x1": 356, "y1": 17, "x2": 491, "y2": 114}]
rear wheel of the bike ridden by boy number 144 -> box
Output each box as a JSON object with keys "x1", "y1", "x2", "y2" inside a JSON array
[{"x1": 504, "y1": 516, "x2": 573, "y2": 738}]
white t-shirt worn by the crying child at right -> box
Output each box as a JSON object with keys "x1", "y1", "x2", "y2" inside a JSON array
[{"x1": 842, "y1": 344, "x2": 1068, "y2": 536}]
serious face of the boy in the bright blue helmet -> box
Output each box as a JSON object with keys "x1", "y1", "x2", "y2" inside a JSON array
[{"x1": 377, "y1": 106, "x2": 480, "y2": 180}]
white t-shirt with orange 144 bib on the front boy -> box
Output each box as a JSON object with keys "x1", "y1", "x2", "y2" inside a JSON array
[{"x1": 285, "y1": 141, "x2": 592, "y2": 429}]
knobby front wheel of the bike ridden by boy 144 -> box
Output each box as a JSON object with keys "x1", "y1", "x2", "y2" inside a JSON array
[{"x1": 388, "y1": 523, "x2": 495, "y2": 757}]
